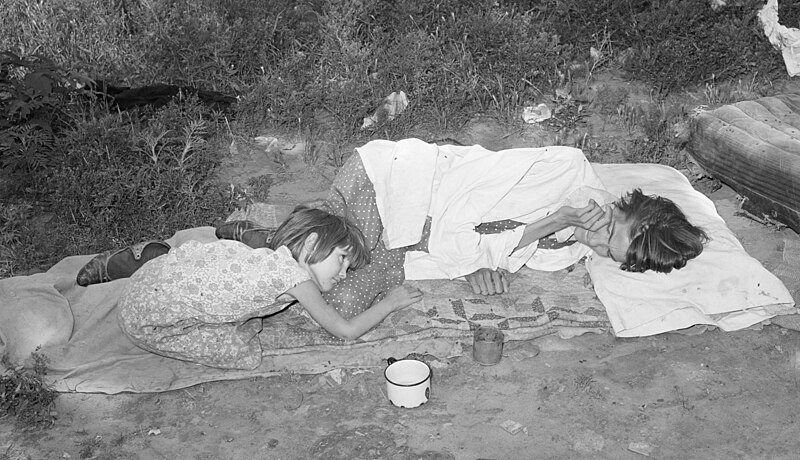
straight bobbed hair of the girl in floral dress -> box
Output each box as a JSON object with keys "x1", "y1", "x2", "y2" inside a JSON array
[{"x1": 269, "y1": 205, "x2": 369, "y2": 268}]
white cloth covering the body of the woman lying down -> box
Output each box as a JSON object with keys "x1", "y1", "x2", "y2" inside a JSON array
[{"x1": 356, "y1": 139, "x2": 614, "y2": 280}]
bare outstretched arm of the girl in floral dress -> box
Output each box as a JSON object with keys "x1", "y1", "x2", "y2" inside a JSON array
[{"x1": 286, "y1": 281, "x2": 422, "y2": 340}]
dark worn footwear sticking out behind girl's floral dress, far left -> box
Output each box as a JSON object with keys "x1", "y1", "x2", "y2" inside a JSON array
[{"x1": 76, "y1": 241, "x2": 170, "y2": 286}]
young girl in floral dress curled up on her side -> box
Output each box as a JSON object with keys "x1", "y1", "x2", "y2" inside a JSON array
[{"x1": 119, "y1": 207, "x2": 422, "y2": 369}]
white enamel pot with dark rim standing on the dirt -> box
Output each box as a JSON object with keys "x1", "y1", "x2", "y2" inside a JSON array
[{"x1": 383, "y1": 358, "x2": 432, "y2": 409}]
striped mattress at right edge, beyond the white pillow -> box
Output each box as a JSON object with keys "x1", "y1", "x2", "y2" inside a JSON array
[{"x1": 689, "y1": 94, "x2": 800, "y2": 231}]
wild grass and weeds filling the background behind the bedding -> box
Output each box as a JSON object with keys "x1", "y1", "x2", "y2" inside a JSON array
[{"x1": 0, "y1": 0, "x2": 788, "y2": 277}]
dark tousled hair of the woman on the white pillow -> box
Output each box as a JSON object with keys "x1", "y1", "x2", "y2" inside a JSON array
[{"x1": 615, "y1": 188, "x2": 708, "y2": 273}]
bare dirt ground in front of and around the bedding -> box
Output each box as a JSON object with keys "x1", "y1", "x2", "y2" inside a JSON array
[{"x1": 0, "y1": 72, "x2": 800, "y2": 459}]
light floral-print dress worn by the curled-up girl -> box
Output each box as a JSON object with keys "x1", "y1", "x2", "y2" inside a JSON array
[{"x1": 118, "y1": 240, "x2": 310, "y2": 369}]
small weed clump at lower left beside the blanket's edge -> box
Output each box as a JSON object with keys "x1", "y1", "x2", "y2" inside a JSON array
[{"x1": 0, "y1": 352, "x2": 58, "y2": 428}]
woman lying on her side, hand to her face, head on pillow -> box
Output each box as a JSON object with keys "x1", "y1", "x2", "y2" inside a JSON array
[{"x1": 310, "y1": 140, "x2": 707, "y2": 316}]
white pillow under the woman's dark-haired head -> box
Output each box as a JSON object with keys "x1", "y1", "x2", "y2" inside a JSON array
[{"x1": 586, "y1": 164, "x2": 797, "y2": 337}]
